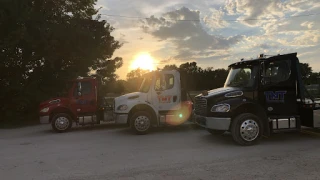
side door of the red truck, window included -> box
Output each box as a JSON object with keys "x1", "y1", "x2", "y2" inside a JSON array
[{"x1": 71, "y1": 81, "x2": 97, "y2": 115}]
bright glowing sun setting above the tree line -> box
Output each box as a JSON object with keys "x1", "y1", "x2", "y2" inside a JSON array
[{"x1": 131, "y1": 53, "x2": 155, "y2": 71}]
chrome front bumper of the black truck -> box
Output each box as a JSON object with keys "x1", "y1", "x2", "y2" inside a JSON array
[{"x1": 194, "y1": 114, "x2": 231, "y2": 131}]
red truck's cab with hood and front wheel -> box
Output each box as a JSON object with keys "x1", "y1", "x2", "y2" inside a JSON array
[{"x1": 39, "y1": 77, "x2": 105, "y2": 132}]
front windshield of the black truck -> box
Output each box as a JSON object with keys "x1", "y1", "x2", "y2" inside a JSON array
[{"x1": 225, "y1": 65, "x2": 259, "y2": 87}]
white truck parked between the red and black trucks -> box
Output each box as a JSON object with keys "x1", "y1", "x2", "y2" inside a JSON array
[{"x1": 114, "y1": 70, "x2": 192, "y2": 134}]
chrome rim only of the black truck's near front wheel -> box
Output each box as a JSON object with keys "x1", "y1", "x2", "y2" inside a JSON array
[{"x1": 240, "y1": 119, "x2": 259, "y2": 141}]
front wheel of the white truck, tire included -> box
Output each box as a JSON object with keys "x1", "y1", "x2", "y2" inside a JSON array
[{"x1": 130, "y1": 111, "x2": 151, "y2": 135}]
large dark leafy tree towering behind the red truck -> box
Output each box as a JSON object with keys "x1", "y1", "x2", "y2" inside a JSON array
[{"x1": 0, "y1": 0, "x2": 122, "y2": 126}]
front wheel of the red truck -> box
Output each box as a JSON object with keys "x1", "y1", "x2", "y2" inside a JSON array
[{"x1": 51, "y1": 113, "x2": 72, "y2": 133}]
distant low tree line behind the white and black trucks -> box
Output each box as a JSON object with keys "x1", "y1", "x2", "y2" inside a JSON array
[{"x1": 106, "y1": 62, "x2": 320, "y2": 94}]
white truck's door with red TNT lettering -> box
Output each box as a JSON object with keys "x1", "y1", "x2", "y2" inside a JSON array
[{"x1": 151, "y1": 71, "x2": 181, "y2": 112}]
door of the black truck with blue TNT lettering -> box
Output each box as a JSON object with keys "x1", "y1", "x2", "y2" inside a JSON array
[{"x1": 259, "y1": 59, "x2": 298, "y2": 117}]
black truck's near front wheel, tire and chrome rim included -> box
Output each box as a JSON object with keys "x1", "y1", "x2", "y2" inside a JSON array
[{"x1": 231, "y1": 113, "x2": 263, "y2": 146}]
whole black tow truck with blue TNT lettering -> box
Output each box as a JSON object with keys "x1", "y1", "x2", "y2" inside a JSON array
[{"x1": 194, "y1": 53, "x2": 320, "y2": 145}]
